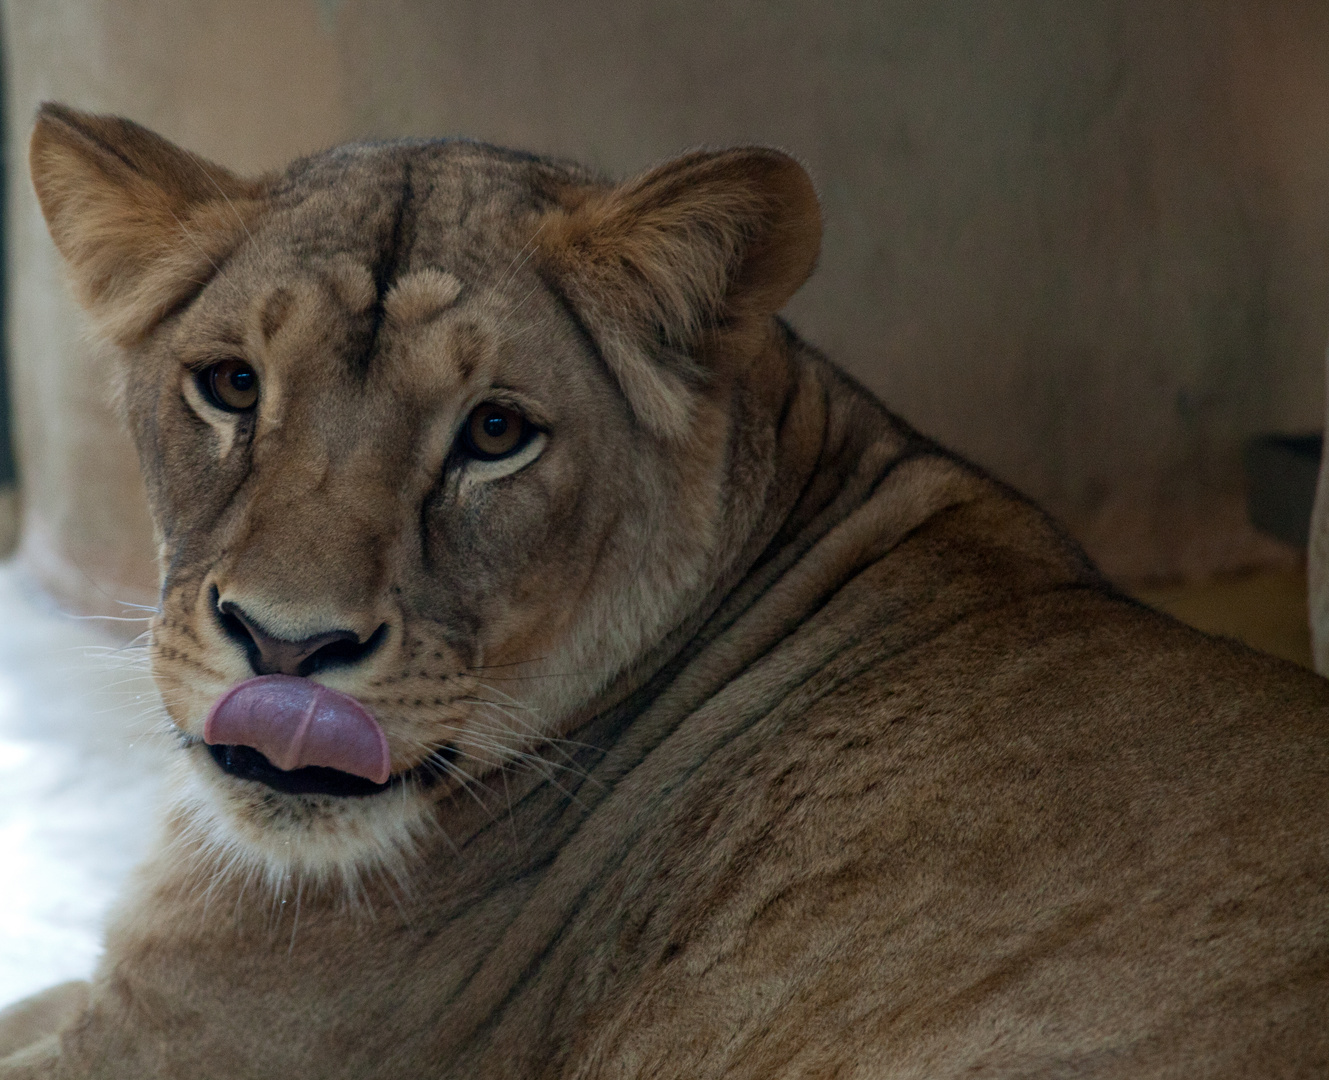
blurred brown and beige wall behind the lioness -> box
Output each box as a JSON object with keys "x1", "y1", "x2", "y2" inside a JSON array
[{"x1": 0, "y1": 0, "x2": 1329, "y2": 619}]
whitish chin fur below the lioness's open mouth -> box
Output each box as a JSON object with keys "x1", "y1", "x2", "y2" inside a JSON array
[{"x1": 171, "y1": 744, "x2": 433, "y2": 902}]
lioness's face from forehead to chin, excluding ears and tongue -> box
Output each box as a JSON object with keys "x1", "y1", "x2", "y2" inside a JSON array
[{"x1": 126, "y1": 175, "x2": 720, "y2": 887}]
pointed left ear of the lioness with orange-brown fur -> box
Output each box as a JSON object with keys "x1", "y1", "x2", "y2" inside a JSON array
[{"x1": 28, "y1": 102, "x2": 262, "y2": 345}]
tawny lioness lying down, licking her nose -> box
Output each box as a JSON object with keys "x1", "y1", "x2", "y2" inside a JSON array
[{"x1": 0, "y1": 98, "x2": 1329, "y2": 1080}]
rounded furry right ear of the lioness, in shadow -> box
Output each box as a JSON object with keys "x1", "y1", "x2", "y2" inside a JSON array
[{"x1": 537, "y1": 147, "x2": 821, "y2": 436}]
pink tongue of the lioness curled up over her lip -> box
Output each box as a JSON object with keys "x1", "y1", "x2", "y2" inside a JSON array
[{"x1": 203, "y1": 675, "x2": 391, "y2": 784}]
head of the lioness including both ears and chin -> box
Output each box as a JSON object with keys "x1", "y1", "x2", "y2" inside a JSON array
[{"x1": 32, "y1": 106, "x2": 816, "y2": 877}]
